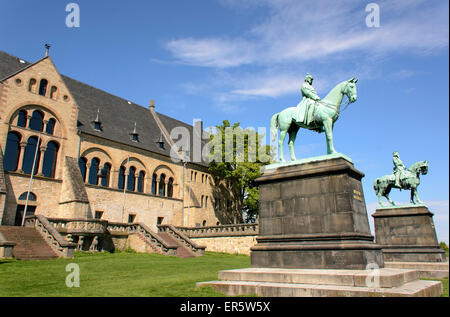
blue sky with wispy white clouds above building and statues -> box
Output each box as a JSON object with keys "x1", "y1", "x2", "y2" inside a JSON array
[{"x1": 0, "y1": 0, "x2": 449, "y2": 243}]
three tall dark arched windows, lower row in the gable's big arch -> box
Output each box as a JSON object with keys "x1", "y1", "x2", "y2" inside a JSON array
[{"x1": 3, "y1": 131, "x2": 59, "y2": 178}]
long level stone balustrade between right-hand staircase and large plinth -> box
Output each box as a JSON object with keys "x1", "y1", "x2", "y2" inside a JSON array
[{"x1": 176, "y1": 223, "x2": 259, "y2": 238}]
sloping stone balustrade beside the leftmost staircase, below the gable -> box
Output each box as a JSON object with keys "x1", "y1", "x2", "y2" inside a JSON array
[{"x1": 25, "y1": 215, "x2": 76, "y2": 258}]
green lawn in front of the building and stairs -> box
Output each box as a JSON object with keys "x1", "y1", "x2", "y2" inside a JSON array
[{"x1": 0, "y1": 252, "x2": 250, "y2": 297}]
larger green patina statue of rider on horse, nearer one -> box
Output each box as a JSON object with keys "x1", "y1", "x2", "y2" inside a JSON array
[{"x1": 270, "y1": 74, "x2": 358, "y2": 162}]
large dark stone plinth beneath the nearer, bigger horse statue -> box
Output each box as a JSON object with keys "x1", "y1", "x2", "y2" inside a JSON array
[{"x1": 251, "y1": 156, "x2": 383, "y2": 270}]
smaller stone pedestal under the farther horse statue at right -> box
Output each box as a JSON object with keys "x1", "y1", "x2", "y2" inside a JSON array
[{"x1": 372, "y1": 205, "x2": 446, "y2": 262}]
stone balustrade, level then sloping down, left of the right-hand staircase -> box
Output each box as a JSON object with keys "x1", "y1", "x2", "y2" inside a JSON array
[{"x1": 108, "y1": 223, "x2": 178, "y2": 256}]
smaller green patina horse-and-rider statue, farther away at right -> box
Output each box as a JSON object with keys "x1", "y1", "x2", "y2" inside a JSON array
[{"x1": 373, "y1": 151, "x2": 428, "y2": 206}]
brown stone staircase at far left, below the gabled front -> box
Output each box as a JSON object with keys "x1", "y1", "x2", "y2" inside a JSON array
[{"x1": 0, "y1": 226, "x2": 58, "y2": 260}]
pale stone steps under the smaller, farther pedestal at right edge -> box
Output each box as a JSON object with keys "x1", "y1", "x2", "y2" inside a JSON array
[{"x1": 384, "y1": 262, "x2": 449, "y2": 279}]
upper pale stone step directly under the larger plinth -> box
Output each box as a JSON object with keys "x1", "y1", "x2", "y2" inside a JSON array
[{"x1": 219, "y1": 268, "x2": 419, "y2": 288}]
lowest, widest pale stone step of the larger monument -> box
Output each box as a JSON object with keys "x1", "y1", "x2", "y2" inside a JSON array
[{"x1": 197, "y1": 280, "x2": 443, "y2": 297}]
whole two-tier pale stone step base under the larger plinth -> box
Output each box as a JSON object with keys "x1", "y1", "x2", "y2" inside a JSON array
[{"x1": 197, "y1": 268, "x2": 443, "y2": 297}]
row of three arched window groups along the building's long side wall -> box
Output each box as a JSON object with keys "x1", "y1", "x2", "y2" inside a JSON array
[{"x1": 78, "y1": 157, "x2": 174, "y2": 197}]
